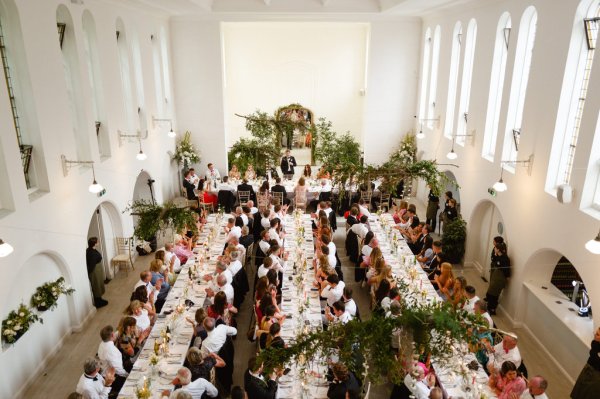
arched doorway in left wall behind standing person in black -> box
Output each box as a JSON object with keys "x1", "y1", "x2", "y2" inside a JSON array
[{"x1": 87, "y1": 201, "x2": 123, "y2": 280}]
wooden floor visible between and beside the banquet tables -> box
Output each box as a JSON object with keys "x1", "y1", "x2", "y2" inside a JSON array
[{"x1": 23, "y1": 216, "x2": 572, "y2": 399}]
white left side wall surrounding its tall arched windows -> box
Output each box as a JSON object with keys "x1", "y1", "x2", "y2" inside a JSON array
[{"x1": 0, "y1": 0, "x2": 178, "y2": 398}]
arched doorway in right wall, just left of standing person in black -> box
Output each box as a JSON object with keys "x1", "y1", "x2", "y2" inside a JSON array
[{"x1": 465, "y1": 200, "x2": 510, "y2": 280}]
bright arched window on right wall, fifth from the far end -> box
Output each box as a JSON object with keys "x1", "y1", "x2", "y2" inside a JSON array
[{"x1": 481, "y1": 12, "x2": 511, "y2": 162}]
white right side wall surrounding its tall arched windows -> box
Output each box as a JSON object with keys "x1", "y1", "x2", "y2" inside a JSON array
[{"x1": 420, "y1": 0, "x2": 600, "y2": 379}]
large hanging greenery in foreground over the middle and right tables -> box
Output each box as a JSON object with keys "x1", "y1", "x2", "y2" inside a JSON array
[{"x1": 259, "y1": 281, "x2": 486, "y2": 383}]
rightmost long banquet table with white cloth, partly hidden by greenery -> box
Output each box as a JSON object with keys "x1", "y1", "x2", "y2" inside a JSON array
[{"x1": 376, "y1": 213, "x2": 497, "y2": 399}]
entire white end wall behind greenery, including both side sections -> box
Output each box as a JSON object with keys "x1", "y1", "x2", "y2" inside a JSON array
[{"x1": 171, "y1": 15, "x2": 421, "y2": 171}]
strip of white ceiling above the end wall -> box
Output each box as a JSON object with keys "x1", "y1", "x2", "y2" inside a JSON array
[{"x1": 125, "y1": 0, "x2": 470, "y2": 16}]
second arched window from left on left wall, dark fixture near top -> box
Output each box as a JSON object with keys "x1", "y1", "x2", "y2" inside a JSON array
[{"x1": 56, "y1": 4, "x2": 92, "y2": 159}]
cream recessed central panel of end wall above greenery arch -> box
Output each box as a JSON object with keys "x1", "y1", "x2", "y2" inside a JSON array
[{"x1": 222, "y1": 22, "x2": 369, "y2": 147}]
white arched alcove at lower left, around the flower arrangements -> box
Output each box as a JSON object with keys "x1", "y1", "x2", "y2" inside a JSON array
[{"x1": 0, "y1": 251, "x2": 76, "y2": 398}]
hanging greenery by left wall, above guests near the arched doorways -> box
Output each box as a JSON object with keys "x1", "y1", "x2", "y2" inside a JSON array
[{"x1": 123, "y1": 200, "x2": 197, "y2": 241}]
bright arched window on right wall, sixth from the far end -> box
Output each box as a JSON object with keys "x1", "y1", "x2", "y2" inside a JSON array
[{"x1": 502, "y1": 6, "x2": 537, "y2": 172}]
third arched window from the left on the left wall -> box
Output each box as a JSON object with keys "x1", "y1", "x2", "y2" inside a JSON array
[{"x1": 81, "y1": 10, "x2": 110, "y2": 158}]
